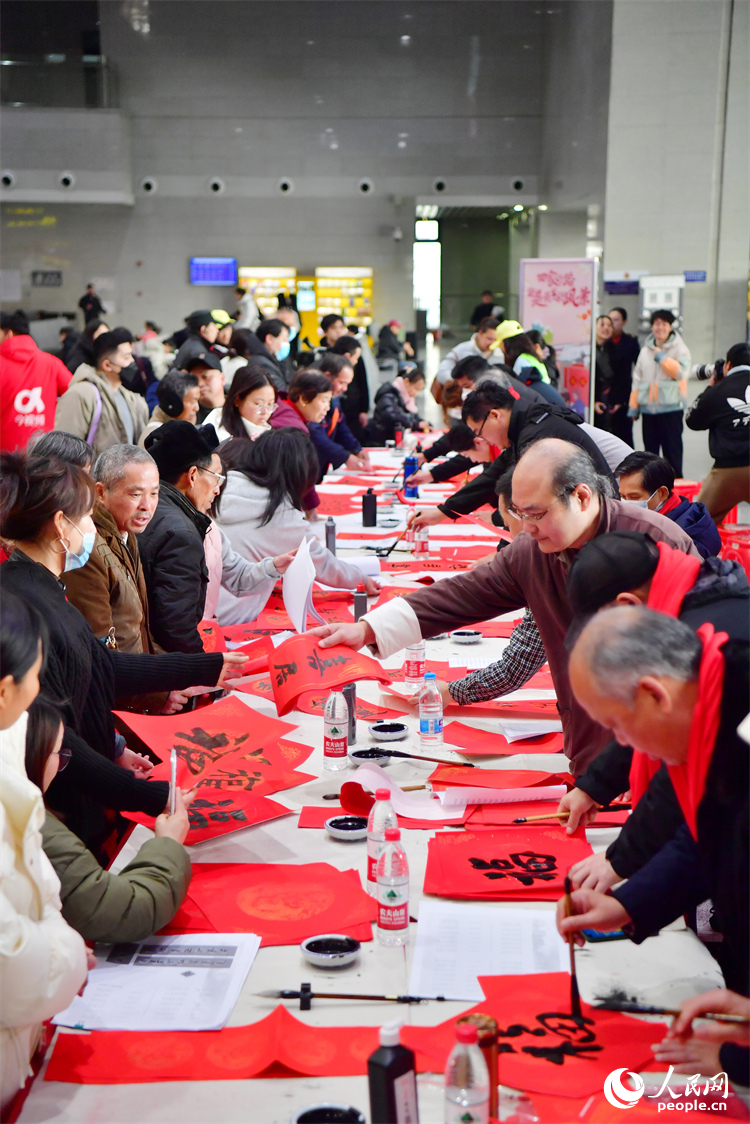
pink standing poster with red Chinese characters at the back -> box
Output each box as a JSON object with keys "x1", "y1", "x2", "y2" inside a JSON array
[{"x1": 518, "y1": 257, "x2": 598, "y2": 419}]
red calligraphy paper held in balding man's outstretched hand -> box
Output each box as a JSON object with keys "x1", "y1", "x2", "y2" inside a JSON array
[{"x1": 269, "y1": 634, "x2": 387, "y2": 715}]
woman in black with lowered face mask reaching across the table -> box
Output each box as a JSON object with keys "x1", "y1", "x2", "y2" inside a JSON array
[{"x1": 0, "y1": 453, "x2": 243, "y2": 847}]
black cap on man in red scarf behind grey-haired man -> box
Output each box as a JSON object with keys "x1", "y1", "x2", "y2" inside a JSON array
[{"x1": 568, "y1": 531, "x2": 659, "y2": 617}]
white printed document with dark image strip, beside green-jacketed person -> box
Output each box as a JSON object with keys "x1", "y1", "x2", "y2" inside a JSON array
[{"x1": 53, "y1": 933, "x2": 261, "y2": 1031}]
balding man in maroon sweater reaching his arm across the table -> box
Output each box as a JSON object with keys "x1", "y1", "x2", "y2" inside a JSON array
[{"x1": 313, "y1": 438, "x2": 697, "y2": 776}]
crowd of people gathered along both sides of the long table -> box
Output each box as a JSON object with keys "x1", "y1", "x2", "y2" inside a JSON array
[{"x1": 0, "y1": 287, "x2": 750, "y2": 1105}]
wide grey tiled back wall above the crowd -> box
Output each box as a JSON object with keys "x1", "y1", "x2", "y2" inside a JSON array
[{"x1": 0, "y1": 0, "x2": 546, "y2": 327}]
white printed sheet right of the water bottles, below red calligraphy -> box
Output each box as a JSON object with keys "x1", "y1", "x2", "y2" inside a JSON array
[{"x1": 409, "y1": 898, "x2": 569, "y2": 1003}]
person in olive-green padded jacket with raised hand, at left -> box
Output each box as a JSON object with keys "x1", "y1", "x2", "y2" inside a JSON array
[{"x1": 26, "y1": 696, "x2": 191, "y2": 944}]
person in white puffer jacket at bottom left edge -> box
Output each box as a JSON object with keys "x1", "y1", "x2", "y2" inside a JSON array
[{"x1": 0, "y1": 593, "x2": 87, "y2": 1120}]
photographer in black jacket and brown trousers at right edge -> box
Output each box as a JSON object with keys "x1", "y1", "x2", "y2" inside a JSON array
[{"x1": 685, "y1": 344, "x2": 750, "y2": 523}]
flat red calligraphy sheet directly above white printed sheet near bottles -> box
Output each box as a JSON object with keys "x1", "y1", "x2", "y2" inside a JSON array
[{"x1": 424, "y1": 824, "x2": 593, "y2": 901}]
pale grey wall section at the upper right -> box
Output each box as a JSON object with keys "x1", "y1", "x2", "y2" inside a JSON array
[{"x1": 604, "y1": 0, "x2": 750, "y2": 361}]
